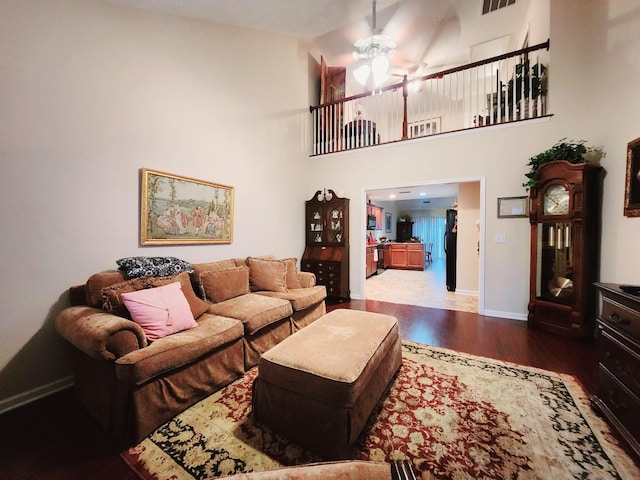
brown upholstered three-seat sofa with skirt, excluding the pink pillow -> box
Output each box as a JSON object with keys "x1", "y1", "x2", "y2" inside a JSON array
[{"x1": 56, "y1": 256, "x2": 326, "y2": 445}]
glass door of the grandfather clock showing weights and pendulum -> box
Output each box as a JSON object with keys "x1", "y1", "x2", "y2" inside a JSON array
[{"x1": 536, "y1": 222, "x2": 574, "y2": 305}]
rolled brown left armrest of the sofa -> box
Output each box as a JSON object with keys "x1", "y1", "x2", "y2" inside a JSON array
[{"x1": 55, "y1": 306, "x2": 147, "y2": 360}]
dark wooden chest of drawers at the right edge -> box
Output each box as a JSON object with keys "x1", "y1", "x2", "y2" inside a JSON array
[{"x1": 591, "y1": 283, "x2": 640, "y2": 459}]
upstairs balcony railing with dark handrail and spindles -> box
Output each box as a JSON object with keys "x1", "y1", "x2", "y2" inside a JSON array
[{"x1": 310, "y1": 40, "x2": 549, "y2": 155}]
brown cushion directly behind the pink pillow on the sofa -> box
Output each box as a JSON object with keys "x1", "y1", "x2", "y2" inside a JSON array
[{"x1": 102, "y1": 272, "x2": 209, "y2": 319}]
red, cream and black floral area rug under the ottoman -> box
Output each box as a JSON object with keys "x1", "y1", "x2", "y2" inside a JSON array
[{"x1": 122, "y1": 342, "x2": 640, "y2": 480}]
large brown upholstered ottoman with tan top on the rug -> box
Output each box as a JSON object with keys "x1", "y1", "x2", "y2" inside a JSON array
[{"x1": 253, "y1": 309, "x2": 402, "y2": 459}]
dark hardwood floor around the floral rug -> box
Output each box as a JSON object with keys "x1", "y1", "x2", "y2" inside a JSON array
[{"x1": 0, "y1": 300, "x2": 596, "y2": 480}]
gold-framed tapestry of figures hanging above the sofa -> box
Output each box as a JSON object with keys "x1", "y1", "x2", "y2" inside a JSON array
[{"x1": 140, "y1": 168, "x2": 233, "y2": 245}]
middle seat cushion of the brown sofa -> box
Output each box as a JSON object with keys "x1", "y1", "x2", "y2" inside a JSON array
[{"x1": 209, "y1": 293, "x2": 293, "y2": 335}]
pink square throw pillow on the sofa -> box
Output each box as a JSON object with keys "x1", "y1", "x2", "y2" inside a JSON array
[{"x1": 121, "y1": 282, "x2": 198, "y2": 342}]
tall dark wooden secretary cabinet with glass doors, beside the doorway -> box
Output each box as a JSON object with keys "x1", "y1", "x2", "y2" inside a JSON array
[{"x1": 300, "y1": 190, "x2": 350, "y2": 299}]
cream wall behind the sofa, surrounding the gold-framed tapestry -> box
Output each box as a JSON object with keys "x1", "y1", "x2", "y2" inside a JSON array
[{"x1": 0, "y1": 0, "x2": 310, "y2": 411}]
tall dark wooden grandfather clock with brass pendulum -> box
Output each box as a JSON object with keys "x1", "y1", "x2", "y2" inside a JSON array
[{"x1": 528, "y1": 160, "x2": 602, "y2": 338}]
